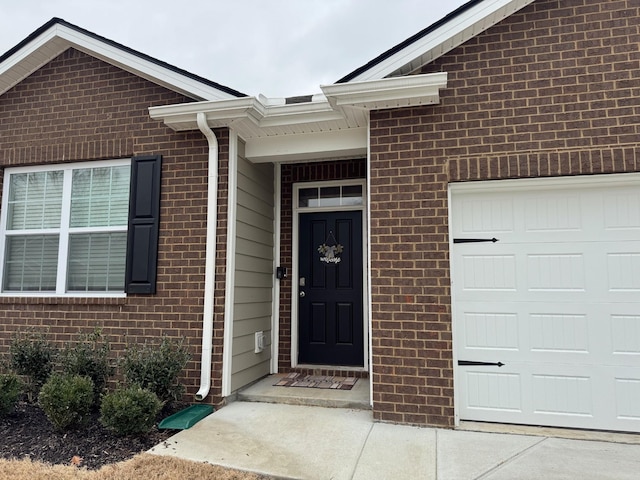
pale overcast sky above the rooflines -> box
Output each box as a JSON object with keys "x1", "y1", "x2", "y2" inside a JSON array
[{"x1": 0, "y1": 0, "x2": 467, "y2": 97}]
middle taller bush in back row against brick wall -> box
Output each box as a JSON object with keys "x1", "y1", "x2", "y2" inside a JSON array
[{"x1": 60, "y1": 330, "x2": 115, "y2": 405}]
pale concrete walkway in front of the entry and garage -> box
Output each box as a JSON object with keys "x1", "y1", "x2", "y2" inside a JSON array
[{"x1": 150, "y1": 401, "x2": 640, "y2": 480}]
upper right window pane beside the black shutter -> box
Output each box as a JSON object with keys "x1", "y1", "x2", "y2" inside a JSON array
[{"x1": 70, "y1": 165, "x2": 130, "y2": 227}]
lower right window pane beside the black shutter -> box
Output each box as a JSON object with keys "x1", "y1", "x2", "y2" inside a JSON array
[{"x1": 67, "y1": 232, "x2": 127, "y2": 292}]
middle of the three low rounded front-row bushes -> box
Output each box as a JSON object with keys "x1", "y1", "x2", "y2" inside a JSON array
[{"x1": 38, "y1": 373, "x2": 93, "y2": 430}]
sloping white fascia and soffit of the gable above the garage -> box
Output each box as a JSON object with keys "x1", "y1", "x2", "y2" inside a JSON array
[{"x1": 351, "y1": 0, "x2": 534, "y2": 82}]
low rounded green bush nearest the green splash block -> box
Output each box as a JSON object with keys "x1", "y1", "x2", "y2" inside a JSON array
[{"x1": 100, "y1": 385, "x2": 162, "y2": 435}]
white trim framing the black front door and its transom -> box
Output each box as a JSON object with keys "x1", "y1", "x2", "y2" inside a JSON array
[{"x1": 291, "y1": 178, "x2": 370, "y2": 371}]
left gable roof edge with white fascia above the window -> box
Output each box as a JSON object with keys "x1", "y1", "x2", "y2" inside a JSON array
[{"x1": 0, "y1": 18, "x2": 246, "y2": 100}]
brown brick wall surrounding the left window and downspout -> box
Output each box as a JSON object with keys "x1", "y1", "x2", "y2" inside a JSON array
[{"x1": 0, "y1": 49, "x2": 228, "y2": 403}]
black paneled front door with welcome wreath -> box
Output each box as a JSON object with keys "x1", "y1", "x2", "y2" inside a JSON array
[{"x1": 298, "y1": 211, "x2": 364, "y2": 366}]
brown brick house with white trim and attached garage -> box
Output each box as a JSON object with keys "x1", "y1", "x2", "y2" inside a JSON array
[{"x1": 0, "y1": 0, "x2": 640, "y2": 432}]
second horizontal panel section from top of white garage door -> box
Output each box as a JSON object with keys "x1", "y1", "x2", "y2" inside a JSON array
[{"x1": 452, "y1": 242, "x2": 640, "y2": 302}]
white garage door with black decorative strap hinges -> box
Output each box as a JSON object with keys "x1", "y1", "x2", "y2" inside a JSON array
[{"x1": 450, "y1": 174, "x2": 640, "y2": 432}]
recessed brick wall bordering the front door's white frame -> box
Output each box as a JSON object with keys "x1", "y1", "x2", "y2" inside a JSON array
[{"x1": 278, "y1": 159, "x2": 367, "y2": 375}]
